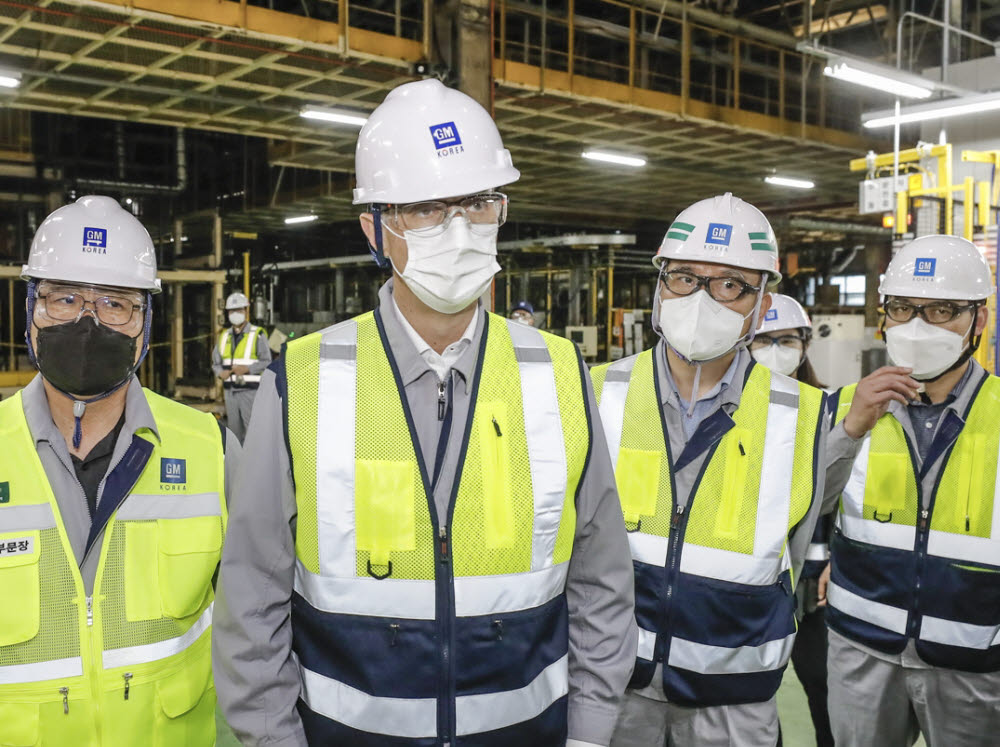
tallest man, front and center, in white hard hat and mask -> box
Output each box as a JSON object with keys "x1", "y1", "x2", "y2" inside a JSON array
[{"x1": 215, "y1": 79, "x2": 636, "y2": 747}]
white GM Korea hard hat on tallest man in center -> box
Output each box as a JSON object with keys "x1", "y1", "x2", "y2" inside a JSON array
[{"x1": 354, "y1": 78, "x2": 521, "y2": 205}]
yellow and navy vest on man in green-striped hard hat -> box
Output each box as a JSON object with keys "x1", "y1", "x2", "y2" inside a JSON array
[{"x1": 592, "y1": 349, "x2": 824, "y2": 707}]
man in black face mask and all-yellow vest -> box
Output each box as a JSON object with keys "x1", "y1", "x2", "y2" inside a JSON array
[{"x1": 0, "y1": 196, "x2": 240, "y2": 747}]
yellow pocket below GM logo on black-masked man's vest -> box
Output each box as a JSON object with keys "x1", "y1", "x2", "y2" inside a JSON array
[{"x1": 156, "y1": 516, "x2": 222, "y2": 618}]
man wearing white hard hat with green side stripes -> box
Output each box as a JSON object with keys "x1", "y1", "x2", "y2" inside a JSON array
[{"x1": 593, "y1": 194, "x2": 827, "y2": 747}]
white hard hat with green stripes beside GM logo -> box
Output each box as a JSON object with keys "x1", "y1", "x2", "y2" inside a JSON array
[{"x1": 653, "y1": 192, "x2": 781, "y2": 280}]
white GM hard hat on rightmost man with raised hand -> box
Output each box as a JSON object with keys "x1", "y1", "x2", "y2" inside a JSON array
[{"x1": 878, "y1": 235, "x2": 995, "y2": 301}]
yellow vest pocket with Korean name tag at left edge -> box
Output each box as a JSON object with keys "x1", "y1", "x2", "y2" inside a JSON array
[{"x1": 0, "y1": 530, "x2": 42, "y2": 644}]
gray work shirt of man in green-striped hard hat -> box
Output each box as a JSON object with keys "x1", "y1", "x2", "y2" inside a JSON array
[{"x1": 634, "y1": 340, "x2": 832, "y2": 701}]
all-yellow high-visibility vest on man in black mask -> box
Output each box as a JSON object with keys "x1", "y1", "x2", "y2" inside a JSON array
[{"x1": 0, "y1": 391, "x2": 226, "y2": 747}]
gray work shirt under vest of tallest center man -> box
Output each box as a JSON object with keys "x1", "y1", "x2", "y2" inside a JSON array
[{"x1": 213, "y1": 280, "x2": 638, "y2": 745}]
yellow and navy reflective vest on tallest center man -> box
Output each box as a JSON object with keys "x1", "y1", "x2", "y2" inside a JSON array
[{"x1": 279, "y1": 312, "x2": 591, "y2": 745}]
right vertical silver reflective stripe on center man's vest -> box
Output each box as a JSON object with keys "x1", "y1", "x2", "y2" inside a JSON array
[{"x1": 512, "y1": 321, "x2": 568, "y2": 568}]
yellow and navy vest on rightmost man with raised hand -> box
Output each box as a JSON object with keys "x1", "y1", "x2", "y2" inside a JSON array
[{"x1": 827, "y1": 376, "x2": 1000, "y2": 672}]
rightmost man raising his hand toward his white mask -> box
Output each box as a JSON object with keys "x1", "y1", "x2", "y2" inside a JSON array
[{"x1": 826, "y1": 236, "x2": 1000, "y2": 747}]
